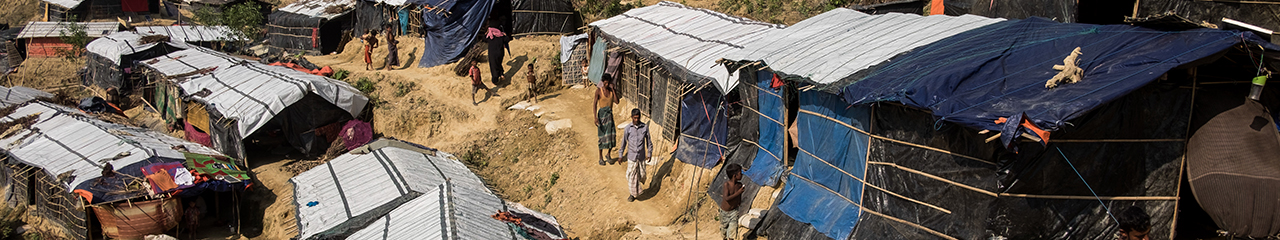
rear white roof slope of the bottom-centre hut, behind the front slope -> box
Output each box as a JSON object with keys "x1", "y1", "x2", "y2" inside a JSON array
[{"x1": 289, "y1": 147, "x2": 488, "y2": 239}]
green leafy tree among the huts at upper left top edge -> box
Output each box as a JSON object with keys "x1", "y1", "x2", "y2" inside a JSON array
[{"x1": 196, "y1": 1, "x2": 262, "y2": 50}]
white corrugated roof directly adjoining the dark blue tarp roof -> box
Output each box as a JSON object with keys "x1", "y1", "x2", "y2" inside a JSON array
[{"x1": 724, "y1": 9, "x2": 1004, "y2": 83}]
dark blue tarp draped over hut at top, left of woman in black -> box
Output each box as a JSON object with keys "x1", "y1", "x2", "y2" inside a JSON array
[{"x1": 410, "y1": 0, "x2": 494, "y2": 68}]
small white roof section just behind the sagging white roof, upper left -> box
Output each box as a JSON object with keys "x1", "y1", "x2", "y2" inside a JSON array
[{"x1": 142, "y1": 46, "x2": 248, "y2": 77}]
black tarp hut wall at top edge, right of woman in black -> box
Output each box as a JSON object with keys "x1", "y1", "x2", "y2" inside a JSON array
[{"x1": 512, "y1": 0, "x2": 582, "y2": 34}]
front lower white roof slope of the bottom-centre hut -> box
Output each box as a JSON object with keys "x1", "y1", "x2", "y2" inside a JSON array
[{"x1": 347, "y1": 184, "x2": 516, "y2": 240}]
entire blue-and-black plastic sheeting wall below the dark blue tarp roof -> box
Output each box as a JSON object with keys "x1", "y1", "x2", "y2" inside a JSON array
[{"x1": 760, "y1": 83, "x2": 1190, "y2": 240}]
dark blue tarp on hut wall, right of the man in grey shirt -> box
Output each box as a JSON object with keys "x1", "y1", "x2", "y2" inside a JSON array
[{"x1": 676, "y1": 87, "x2": 728, "y2": 169}]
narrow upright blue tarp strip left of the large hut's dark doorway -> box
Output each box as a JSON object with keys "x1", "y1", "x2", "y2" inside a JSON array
[{"x1": 742, "y1": 70, "x2": 787, "y2": 186}]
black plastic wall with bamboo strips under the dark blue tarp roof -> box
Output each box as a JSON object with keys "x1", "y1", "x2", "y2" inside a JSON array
[{"x1": 760, "y1": 82, "x2": 1190, "y2": 240}]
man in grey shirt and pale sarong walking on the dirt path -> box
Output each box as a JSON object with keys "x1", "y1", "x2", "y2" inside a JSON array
[{"x1": 618, "y1": 109, "x2": 653, "y2": 202}]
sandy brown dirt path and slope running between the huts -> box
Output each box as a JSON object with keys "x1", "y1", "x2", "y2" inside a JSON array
[{"x1": 291, "y1": 36, "x2": 737, "y2": 239}]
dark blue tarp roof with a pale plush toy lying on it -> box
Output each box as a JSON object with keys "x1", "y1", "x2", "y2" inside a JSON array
[{"x1": 833, "y1": 18, "x2": 1277, "y2": 134}]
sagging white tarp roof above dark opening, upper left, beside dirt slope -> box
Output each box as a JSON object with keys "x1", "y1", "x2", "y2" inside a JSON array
[{"x1": 175, "y1": 60, "x2": 369, "y2": 137}]
